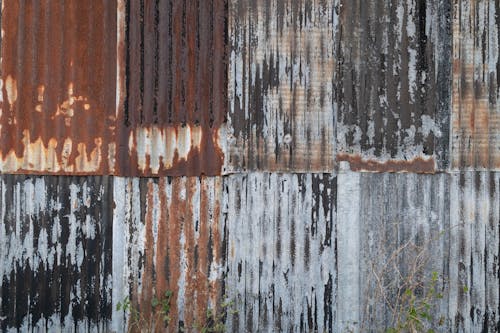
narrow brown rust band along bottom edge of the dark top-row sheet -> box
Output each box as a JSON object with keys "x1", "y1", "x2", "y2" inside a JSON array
[{"x1": 337, "y1": 154, "x2": 436, "y2": 173}]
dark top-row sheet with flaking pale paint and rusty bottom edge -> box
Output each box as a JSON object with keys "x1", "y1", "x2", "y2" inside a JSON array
[{"x1": 335, "y1": 0, "x2": 451, "y2": 172}]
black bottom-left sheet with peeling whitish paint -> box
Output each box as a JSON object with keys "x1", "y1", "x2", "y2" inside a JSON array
[{"x1": 0, "y1": 175, "x2": 113, "y2": 332}]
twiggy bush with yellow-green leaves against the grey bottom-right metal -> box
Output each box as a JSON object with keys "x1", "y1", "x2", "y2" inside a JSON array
[{"x1": 361, "y1": 228, "x2": 460, "y2": 333}]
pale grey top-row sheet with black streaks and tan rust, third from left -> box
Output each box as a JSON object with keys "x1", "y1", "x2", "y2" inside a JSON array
[{"x1": 224, "y1": 0, "x2": 338, "y2": 173}]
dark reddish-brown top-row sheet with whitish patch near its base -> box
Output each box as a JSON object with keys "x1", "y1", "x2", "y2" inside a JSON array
[{"x1": 116, "y1": 0, "x2": 227, "y2": 176}]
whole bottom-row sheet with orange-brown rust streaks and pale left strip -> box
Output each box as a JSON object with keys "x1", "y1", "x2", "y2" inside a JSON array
[{"x1": 112, "y1": 177, "x2": 224, "y2": 331}]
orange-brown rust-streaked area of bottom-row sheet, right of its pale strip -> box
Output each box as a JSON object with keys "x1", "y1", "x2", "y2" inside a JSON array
[{"x1": 134, "y1": 177, "x2": 222, "y2": 332}]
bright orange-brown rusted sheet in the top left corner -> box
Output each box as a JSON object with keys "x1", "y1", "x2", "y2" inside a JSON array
[{"x1": 0, "y1": 0, "x2": 116, "y2": 174}]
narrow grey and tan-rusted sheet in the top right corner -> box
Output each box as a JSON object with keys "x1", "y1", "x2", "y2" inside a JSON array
[{"x1": 451, "y1": 0, "x2": 500, "y2": 170}]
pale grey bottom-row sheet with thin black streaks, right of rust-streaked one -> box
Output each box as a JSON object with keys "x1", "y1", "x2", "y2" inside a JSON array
[{"x1": 222, "y1": 173, "x2": 338, "y2": 332}]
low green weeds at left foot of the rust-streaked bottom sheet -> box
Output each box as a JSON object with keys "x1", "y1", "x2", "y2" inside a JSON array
[{"x1": 116, "y1": 291, "x2": 173, "y2": 332}]
